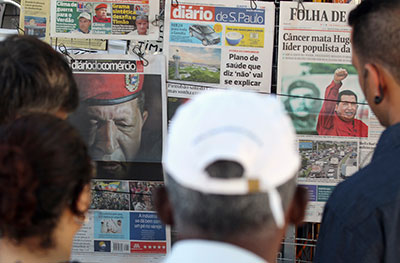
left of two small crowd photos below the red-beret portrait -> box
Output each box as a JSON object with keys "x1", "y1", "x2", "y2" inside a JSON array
[{"x1": 90, "y1": 181, "x2": 129, "y2": 210}]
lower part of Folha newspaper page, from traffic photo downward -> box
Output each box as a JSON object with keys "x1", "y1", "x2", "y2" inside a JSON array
[{"x1": 297, "y1": 136, "x2": 361, "y2": 222}]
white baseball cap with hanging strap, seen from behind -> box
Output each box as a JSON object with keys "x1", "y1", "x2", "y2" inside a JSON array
[{"x1": 163, "y1": 90, "x2": 300, "y2": 227}]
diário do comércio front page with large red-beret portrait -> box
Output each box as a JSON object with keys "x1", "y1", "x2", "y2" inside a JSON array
[{"x1": 69, "y1": 54, "x2": 170, "y2": 262}]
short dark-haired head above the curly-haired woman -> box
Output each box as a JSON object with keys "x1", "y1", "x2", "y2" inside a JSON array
[{"x1": 0, "y1": 35, "x2": 79, "y2": 123}]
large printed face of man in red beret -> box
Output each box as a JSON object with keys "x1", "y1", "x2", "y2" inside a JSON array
[{"x1": 70, "y1": 74, "x2": 149, "y2": 174}]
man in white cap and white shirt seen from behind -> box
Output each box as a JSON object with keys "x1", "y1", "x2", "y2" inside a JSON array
[{"x1": 154, "y1": 91, "x2": 307, "y2": 263}]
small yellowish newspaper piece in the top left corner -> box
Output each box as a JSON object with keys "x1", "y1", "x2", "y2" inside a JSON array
[{"x1": 19, "y1": 0, "x2": 50, "y2": 42}]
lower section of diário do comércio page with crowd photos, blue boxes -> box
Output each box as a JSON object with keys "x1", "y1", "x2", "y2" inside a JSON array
[{"x1": 72, "y1": 180, "x2": 171, "y2": 263}]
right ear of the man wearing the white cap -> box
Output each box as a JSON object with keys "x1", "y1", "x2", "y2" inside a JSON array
[{"x1": 288, "y1": 186, "x2": 308, "y2": 225}]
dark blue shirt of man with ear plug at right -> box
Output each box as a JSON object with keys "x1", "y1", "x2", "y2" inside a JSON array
[{"x1": 314, "y1": 123, "x2": 400, "y2": 263}]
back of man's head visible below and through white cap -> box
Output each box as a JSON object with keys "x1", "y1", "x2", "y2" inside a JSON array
[{"x1": 166, "y1": 169, "x2": 296, "y2": 240}]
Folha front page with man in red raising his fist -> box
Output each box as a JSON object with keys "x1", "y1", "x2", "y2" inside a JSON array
[{"x1": 277, "y1": 2, "x2": 383, "y2": 222}]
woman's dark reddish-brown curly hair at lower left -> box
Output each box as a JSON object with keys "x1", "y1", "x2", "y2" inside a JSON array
[{"x1": 0, "y1": 114, "x2": 93, "y2": 248}]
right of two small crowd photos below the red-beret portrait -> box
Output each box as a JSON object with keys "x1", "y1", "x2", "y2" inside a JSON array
[{"x1": 129, "y1": 181, "x2": 163, "y2": 211}]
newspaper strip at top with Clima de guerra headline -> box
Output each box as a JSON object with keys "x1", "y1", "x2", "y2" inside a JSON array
[{"x1": 51, "y1": 0, "x2": 159, "y2": 40}]
